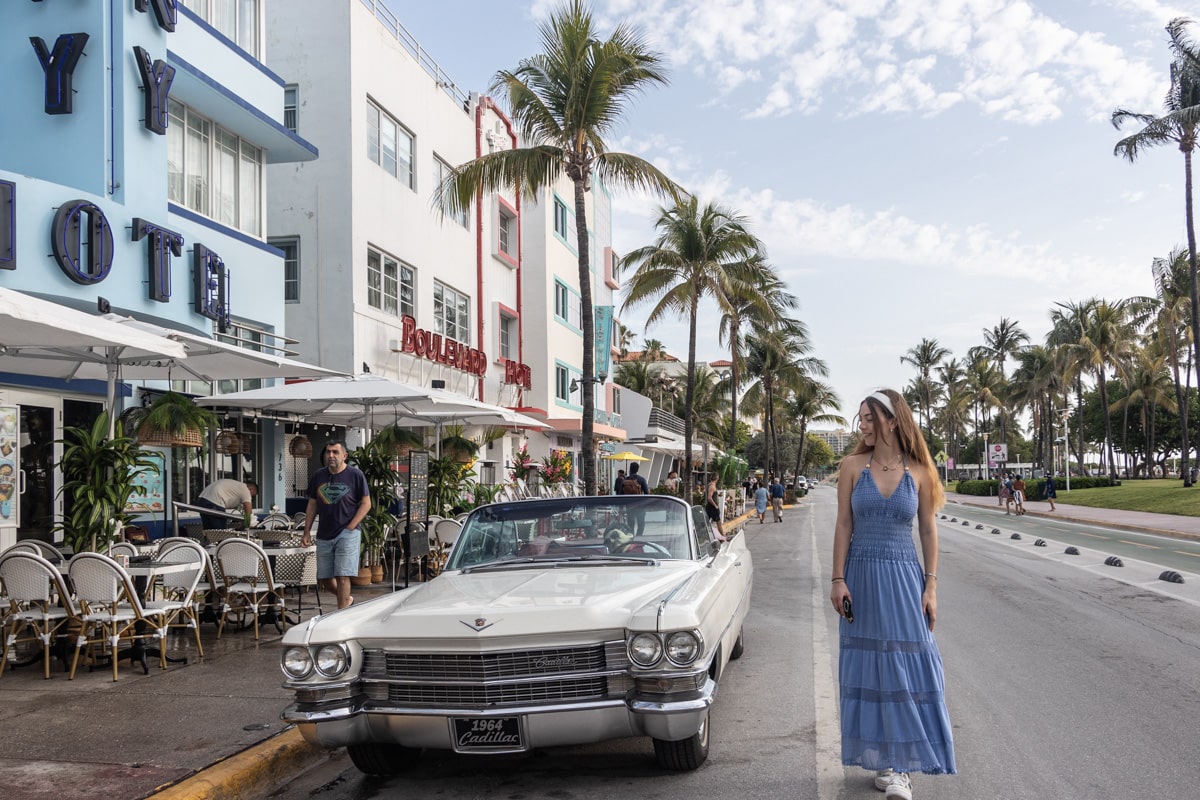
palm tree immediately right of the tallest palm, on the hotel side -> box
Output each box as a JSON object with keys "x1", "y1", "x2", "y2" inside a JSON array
[{"x1": 622, "y1": 197, "x2": 758, "y2": 497}]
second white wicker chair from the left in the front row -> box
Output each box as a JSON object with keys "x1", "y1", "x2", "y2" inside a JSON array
[{"x1": 68, "y1": 553, "x2": 170, "y2": 680}]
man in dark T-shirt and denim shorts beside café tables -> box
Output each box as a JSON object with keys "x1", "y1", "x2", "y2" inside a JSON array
[{"x1": 300, "y1": 441, "x2": 371, "y2": 608}]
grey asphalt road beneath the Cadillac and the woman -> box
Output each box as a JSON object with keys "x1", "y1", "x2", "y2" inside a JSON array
[{"x1": 271, "y1": 486, "x2": 1200, "y2": 800}]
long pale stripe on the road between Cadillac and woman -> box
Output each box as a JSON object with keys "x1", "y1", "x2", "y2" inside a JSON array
[{"x1": 808, "y1": 511, "x2": 846, "y2": 800}]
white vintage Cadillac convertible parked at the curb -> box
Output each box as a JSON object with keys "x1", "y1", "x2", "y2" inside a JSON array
[{"x1": 282, "y1": 495, "x2": 752, "y2": 775}]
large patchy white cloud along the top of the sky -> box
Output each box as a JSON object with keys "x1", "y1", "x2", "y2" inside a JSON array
[{"x1": 595, "y1": 0, "x2": 1168, "y2": 125}]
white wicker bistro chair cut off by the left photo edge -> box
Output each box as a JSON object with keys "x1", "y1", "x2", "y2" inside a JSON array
[{"x1": 0, "y1": 548, "x2": 79, "y2": 678}]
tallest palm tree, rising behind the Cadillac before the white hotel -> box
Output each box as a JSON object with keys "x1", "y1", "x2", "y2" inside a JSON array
[{"x1": 446, "y1": 0, "x2": 679, "y2": 494}]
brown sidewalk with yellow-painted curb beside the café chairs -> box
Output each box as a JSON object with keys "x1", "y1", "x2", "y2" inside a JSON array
[{"x1": 0, "y1": 583, "x2": 391, "y2": 800}]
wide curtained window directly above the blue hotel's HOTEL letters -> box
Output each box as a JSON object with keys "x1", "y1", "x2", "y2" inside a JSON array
[{"x1": 167, "y1": 100, "x2": 263, "y2": 236}]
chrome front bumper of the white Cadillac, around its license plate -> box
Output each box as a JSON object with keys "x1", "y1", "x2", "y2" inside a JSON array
[{"x1": 281, "y1": 678, "x2": 716, "y2": 752}]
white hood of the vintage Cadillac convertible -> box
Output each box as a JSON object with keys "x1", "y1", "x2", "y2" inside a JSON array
[{"x1": 288, "y1": 561, "x2": 701, "y2": 642}]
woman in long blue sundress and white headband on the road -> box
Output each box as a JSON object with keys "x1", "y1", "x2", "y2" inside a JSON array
[{"x1": 829, "y1": 389, "x2": 956, "y2": 800}]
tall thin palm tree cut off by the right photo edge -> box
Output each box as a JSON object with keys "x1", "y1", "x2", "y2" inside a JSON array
[{"x1": 1112, "y1": 17, "x2": 1200, "y2": 486}]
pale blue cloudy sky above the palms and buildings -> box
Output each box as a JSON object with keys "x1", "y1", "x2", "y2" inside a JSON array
[{"x1": 386, "y1": 0, "x2": 1200, "y2": 427}]
